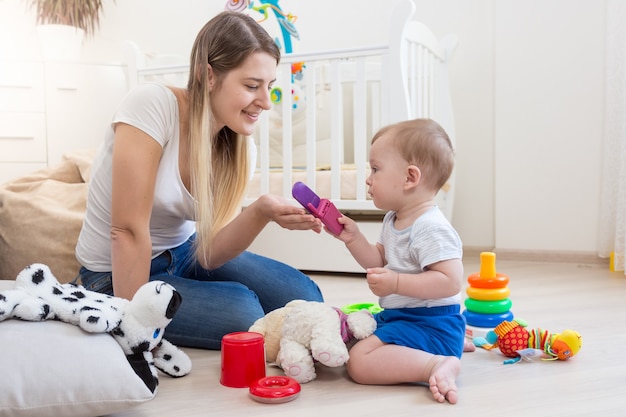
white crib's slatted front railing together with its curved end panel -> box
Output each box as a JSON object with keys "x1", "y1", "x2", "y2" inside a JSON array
[{"x1": 245, "y1": 0, "x2": 456, "y2": 218}]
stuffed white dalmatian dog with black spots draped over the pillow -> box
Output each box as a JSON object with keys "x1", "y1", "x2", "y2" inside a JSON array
[{"x1": 0, "y1": 264, "x2": 191, "y2": 392}]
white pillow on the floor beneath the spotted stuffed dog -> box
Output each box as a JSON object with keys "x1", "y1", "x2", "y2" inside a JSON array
[{"x1": 0, "y1": 296, "x2": 154, "y2": 417}]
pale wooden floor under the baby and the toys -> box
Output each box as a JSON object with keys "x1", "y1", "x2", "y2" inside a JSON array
[{"x1": 115, "y1": 259, "x2": 626, "y2": 417}]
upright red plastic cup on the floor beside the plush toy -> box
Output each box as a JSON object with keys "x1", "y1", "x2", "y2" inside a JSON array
[{"x1": 220, "y1": 332, "x2": 265, "y2": 388}]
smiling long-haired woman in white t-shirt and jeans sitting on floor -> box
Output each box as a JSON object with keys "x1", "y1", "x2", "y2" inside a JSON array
[{"x1": 76, "y1": 12, "x2": 322, "y2": 349}]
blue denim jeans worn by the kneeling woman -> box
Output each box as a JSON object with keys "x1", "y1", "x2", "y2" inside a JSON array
[{"x1": 79, "y1": 237, "x2": 323, "y2": 349}]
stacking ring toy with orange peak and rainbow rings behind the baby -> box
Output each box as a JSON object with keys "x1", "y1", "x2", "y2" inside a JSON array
[{"x1": 463, "y1": 252, "x2": 513, "y2": 337}]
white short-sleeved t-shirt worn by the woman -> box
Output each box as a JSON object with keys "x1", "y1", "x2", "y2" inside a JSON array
[{"x1": 76, "y1": 84, "x2": 195, "y2": 272}]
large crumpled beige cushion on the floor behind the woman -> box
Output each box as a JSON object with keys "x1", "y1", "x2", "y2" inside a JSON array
[{"x1": 0, "y1": 150, "x2": 95, "y2": 283}]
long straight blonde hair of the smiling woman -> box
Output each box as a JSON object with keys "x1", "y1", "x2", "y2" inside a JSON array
[{"x1": 187, "y1": 11, "x2": 280, "y2": 265}]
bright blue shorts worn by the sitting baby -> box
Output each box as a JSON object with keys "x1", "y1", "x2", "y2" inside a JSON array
[{"x1": 374, "y1": 304, "x2": 465, "y2": 358}]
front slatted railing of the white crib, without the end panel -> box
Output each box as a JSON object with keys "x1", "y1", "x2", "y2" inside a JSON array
[{"x1": 245, "y1": 47, "x2": 389, "y2": 211}]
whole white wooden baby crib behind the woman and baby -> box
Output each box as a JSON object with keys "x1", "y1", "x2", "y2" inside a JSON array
[{"x1": 125, "y1": 0, "x2": 457, "y2": 272}]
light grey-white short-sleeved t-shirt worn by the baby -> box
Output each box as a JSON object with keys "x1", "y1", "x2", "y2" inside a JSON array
[{"x1": 378, "y1": 207, "x2": 463, "y2": 308}]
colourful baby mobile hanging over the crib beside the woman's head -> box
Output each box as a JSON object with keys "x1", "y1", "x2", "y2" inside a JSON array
[{"x1": 225, "y1": 0, "x2": 305, "y2": 110}]
